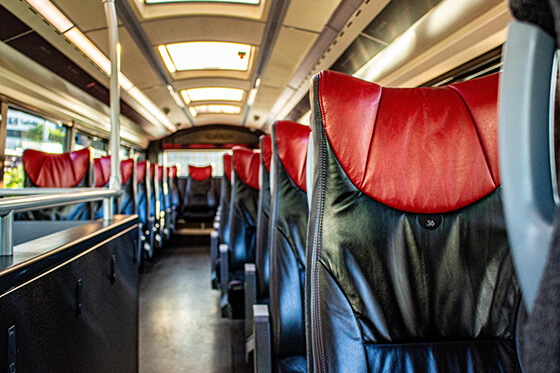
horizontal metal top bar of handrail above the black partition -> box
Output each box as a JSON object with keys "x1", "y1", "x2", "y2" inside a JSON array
[{"x1": 0, "y1": 188, "x2": 121, "y2": 216}]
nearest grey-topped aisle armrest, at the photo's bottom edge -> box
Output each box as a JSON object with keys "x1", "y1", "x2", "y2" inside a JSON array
[{"x1": 253, "y1": 304, "x2": 272, "y2": 373}]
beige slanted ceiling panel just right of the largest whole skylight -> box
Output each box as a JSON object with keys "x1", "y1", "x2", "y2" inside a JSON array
[{"x1": 262, "y1": 27, "x2": 317, "y2": 88}]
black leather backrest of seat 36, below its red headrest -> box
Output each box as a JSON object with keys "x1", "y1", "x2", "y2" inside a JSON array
[{"x1": 306, "y1": 71, "x2": 521, "y2": 373}]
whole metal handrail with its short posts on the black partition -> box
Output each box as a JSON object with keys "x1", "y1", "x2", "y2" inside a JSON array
[{"x1": 0, "y1": 188, "x2": 121, "y2": 256}]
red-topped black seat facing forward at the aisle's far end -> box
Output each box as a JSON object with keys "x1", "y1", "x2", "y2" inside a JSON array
[{"x1": 184, "y1": 165, "x2": 217, "y2": 220}]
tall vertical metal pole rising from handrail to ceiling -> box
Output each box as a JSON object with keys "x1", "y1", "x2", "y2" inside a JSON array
[{"x1": 103, "y1": 0, "x2": 121, "y2": 220}]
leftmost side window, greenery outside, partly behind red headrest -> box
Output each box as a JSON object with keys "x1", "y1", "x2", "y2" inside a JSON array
[{"x1": 4, "y1": 108, "x2": 67, "y2": 188}]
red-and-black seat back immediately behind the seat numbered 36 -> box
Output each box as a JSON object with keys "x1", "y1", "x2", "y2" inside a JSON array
[{"x1": 269, "y1": 121, "x2": 310, "y2": 358}]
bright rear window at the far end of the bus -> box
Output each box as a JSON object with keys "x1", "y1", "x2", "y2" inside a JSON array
[{"x1": 165, "y1": 150, "x2": 226, "y2": 177}]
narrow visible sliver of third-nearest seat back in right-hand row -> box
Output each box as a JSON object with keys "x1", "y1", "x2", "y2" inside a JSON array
[{"x1": 255, "y1": 135, "x2": 272, "y2": 299}]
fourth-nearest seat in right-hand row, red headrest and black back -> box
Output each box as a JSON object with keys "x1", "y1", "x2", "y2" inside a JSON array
[{"x1": 228, "y1": 147, "x2": 260, "y2": 318}]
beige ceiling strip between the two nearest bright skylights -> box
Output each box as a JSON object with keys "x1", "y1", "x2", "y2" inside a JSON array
[{"x1": 142, "y1": 16, "x2": 264, "y2": 46}]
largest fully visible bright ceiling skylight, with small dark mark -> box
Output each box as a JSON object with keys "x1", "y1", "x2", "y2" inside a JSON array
[{"x1": 158, "y1": 41, "x2": 252, "y2": 73}]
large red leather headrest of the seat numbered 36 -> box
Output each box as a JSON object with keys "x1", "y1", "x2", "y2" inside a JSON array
[{"x1": 318, "y1": 71, "x2": 500, "y2": 213}]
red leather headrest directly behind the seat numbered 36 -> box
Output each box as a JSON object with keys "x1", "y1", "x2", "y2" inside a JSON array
[{"x1": 273, "y1": 120, "x2": 311, "y2": 192}]
